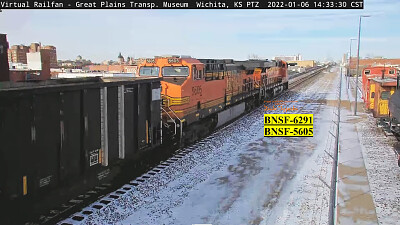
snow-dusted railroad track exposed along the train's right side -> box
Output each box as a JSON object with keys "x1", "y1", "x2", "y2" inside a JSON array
[{"x1": 52, "y1": 67, "x2": 326, "y2": 225}]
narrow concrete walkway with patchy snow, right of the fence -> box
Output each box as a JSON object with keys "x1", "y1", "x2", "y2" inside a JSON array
[{"x1": 336, "y1": 76, "x2": 378, "y2": 225}]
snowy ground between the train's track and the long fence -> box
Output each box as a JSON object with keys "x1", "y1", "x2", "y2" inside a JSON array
[{"x1": 61, "y1": 68, "x2": 344, "y2": 224}]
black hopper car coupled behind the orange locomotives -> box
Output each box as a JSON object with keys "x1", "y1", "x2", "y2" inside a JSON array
[{"x1": 0, "y1": 78, "x2": 162, "y2": 224}]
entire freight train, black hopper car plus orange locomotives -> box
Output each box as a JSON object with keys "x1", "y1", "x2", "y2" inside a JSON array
[{"x1": 0, "y1": 56, "x2": 288, "y2": 224}]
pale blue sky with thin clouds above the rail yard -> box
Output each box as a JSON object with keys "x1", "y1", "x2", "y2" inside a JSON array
[{"x1": 0, "y1": 0, "x2": 400, "y2": 62}]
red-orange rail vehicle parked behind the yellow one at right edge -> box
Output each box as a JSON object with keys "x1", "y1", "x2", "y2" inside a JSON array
[{"x1": 362, "y1": 66, "x2": 398, "y2": 109}]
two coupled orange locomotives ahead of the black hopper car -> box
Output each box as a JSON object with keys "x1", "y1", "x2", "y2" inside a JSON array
[{"x1": 139, "y1": 56, "x2": 288, "y2": 143}]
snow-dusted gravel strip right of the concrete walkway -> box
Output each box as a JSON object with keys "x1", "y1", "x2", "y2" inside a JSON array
[{"x1": 357, "y1": 105, "x2": 400, "y2": 224}]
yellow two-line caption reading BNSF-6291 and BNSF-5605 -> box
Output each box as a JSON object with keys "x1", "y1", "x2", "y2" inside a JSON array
[{"x1": 264, "y1": 114, "x2": 314, "y2": 137}]
